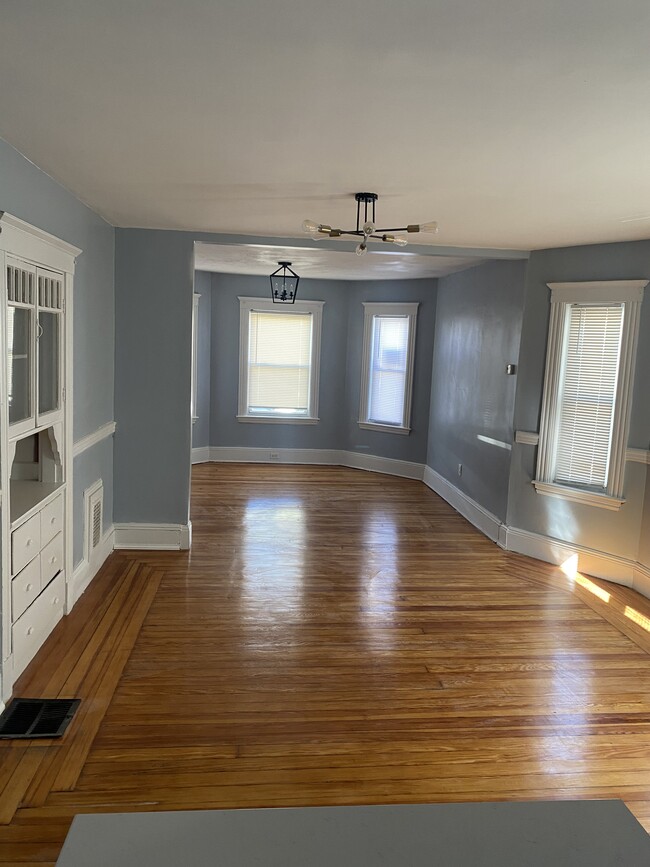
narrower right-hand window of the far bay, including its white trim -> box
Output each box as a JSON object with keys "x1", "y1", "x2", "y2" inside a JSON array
[{"x1": 359, "y1": 303, "x2": 418, "y2": 434}]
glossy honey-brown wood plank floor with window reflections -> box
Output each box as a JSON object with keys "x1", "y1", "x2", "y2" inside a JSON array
[{"x1": 0, "y1": 464, "x2": 650, "y2": 867}]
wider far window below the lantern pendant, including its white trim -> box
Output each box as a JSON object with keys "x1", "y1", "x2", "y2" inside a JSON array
[{"x1": 237, "y1": 298, "x2": 323, "y2": 424}]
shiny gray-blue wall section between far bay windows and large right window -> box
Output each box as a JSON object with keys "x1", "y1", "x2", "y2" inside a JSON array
[{"x1": 427, "y1": 262, "x2": 526, "y2": 521}]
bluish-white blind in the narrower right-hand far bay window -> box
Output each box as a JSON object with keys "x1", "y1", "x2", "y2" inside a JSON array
[{"x1": 368, "y1": 316, "x2": 410, "y2": 425}]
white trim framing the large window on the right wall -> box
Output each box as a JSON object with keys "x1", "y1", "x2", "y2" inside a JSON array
[{"x1": 533, "y1": 280, "x2": 649, "y2": 510}]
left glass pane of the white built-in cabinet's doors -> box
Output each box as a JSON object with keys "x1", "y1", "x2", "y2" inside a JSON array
[{"x1": 7, "y1": 305, "x2": 34, "y2": 425}]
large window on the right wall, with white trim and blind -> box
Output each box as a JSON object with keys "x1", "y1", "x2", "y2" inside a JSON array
[{"x1": 534, "y1": 280, "x2": 647, "y2": 509}]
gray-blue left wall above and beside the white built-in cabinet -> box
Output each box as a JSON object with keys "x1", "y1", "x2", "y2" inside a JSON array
[{"x1": 0, "y1": 139, "x2": 115, "y2": 564}]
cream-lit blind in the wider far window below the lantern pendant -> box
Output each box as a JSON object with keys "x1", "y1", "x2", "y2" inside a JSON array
[{"x1": 247, "y1": 310, "x2": 312, "y2": 416}]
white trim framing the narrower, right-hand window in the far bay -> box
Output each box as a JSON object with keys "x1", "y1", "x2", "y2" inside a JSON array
[{"x1": 359, "y1": 301, "x2": 420, "y2": 435}]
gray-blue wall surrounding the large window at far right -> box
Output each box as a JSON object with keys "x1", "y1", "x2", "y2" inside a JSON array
[{"x1": 508, "y1": 241, "x2": 650, "y2": 560}]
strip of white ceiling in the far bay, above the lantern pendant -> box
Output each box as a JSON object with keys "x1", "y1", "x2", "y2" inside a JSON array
[{"x1": 194, "y1": 243, "x2": 481, "y2": 280}]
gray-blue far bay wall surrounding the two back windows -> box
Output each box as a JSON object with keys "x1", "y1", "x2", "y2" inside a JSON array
[{"x1": 193, "y1": 272, "x2": 435, "y2": 463}]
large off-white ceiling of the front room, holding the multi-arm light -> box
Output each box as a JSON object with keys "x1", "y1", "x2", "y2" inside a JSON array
[{"x1": 0, "y1": 0, "x2": 650, "y2": 249}]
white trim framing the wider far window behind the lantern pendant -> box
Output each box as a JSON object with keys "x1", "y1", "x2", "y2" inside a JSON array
[{"x1": 237, "y1": 295, "x2": 325, "y2": 424}]
